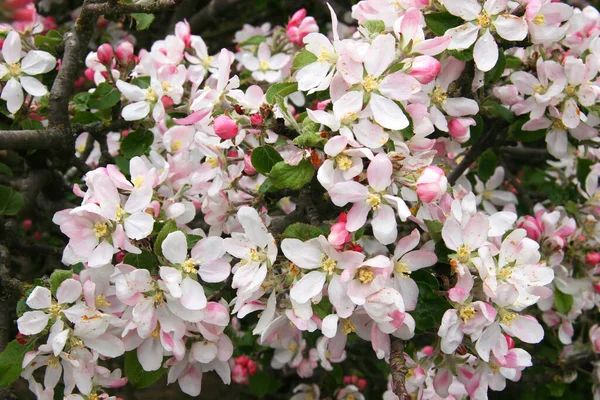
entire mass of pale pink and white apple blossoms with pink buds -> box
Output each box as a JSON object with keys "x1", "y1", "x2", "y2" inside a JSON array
[{"x1": 0, "y1": 0, "x2": 600, "y2": 400}]
